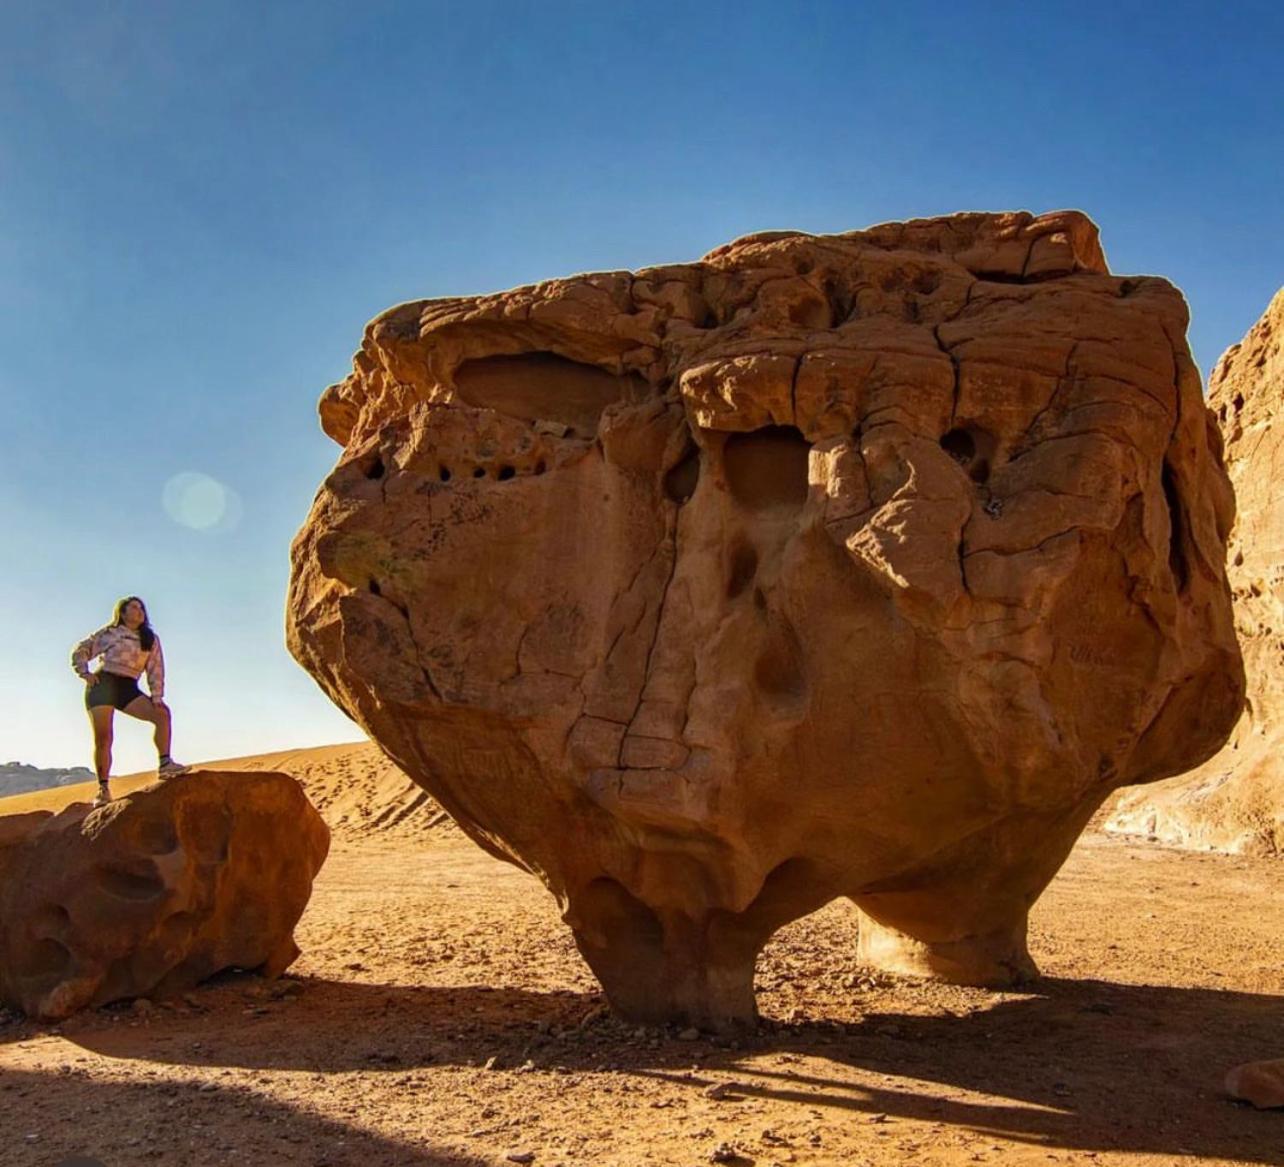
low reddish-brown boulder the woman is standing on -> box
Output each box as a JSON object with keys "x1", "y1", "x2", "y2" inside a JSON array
[{"x1": 0, "y1": 770, "x2": 330, "y2": 1019}]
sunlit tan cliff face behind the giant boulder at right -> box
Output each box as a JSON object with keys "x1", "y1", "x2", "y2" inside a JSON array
[{"x1": 1107, "y1": 289, "x2": 1284, "y2": 855}]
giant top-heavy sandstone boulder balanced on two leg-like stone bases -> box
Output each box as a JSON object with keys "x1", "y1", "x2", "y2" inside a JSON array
[{"x1": 288, "y1": 213, "x2": 1243, "y2": 1023}]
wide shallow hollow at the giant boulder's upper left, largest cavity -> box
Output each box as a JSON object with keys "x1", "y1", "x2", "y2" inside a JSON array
[{"x1": 455, "y1": 352, "x2": 651, "y2": 437}]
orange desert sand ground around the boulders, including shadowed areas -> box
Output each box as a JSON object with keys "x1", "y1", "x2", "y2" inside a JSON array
[{"x1": 0, "y1": 743, "x2": 1284, "y2": 1167}]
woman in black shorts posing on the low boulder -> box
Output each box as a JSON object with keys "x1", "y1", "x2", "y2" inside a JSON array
[{"x1": 72, "y1": 596, "x2": 186, "y2": 806}]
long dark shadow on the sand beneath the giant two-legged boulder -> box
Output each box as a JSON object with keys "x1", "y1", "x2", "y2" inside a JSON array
[{"x1": 17, "y1": 978, "x2": 1284, "y2": 1163}]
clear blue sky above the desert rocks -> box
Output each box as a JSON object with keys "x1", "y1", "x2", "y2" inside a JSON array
[{"x1": 0, "y1": 0, "x2": 1284, "y2": 773}]
